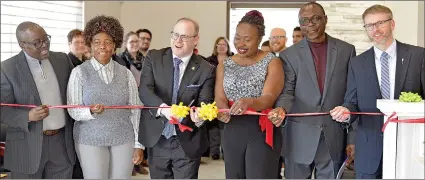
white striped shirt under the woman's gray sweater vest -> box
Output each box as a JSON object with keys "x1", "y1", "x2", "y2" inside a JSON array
[{"x1": 67, "y1": 58, "x2": 144, "y2": 149}]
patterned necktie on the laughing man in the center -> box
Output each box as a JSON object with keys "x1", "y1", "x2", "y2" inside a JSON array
[{"x1": 162, "y1": 58, "x2": 183, "y2": 139}]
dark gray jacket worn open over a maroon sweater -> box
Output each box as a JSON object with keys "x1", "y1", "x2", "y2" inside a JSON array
[{"x1": 276, "y1": 35, "x2": 356, "y2": 164}]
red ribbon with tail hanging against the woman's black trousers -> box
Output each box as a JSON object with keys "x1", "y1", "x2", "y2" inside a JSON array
[{"x1": 227, "y1": 101, "x2": 274, "y2": 149}]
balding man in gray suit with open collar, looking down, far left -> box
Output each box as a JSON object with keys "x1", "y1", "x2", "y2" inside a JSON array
[{"x1": 1, "y1": 22, "x2": 75, "y2": 179}]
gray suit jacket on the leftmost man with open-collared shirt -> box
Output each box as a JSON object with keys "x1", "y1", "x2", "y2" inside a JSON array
[{"x1": 1, "y1": 51, "x2": 75, "y2": 174}]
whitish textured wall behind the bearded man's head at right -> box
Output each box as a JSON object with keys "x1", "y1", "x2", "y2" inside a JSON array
[{"x1": 318, "y1": 1, "x2": 424, "y2": 54}]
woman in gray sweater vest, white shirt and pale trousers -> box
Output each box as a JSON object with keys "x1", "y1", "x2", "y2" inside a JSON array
[{"x1": 67, "y1": 15, "x2": 144, "y2": 179}]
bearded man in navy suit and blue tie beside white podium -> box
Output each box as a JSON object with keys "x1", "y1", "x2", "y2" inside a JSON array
[{"x1": 331, "y1": 5, "x2": 425, "y2": 179}]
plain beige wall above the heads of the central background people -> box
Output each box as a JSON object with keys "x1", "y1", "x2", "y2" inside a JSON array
[{"x1": 84, "y1": 1, "x2": 227, "y2": 56}]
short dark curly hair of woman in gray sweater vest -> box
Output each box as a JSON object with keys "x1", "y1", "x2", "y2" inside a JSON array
[{"x1": 83, "y1": 15, "x2": 124, "y2": 48}]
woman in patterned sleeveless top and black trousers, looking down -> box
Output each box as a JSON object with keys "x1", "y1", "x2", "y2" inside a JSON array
[{"x1": 215, "y1": 10, "x2": 284, "y2": 179}]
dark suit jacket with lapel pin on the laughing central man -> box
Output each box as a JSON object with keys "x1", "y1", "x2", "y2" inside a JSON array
[{"x1": 139, "y1": 48, "x2": 215, "y2": 158}]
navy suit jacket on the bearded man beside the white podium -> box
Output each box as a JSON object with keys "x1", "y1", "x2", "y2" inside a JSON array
[{"x1": 343, "y1": 41, "x2": 425, "y2": 174}]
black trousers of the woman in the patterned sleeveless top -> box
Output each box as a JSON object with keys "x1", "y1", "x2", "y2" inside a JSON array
[{"x1": 222, "y1": 115, "x2": 282, "y2": 179}]
